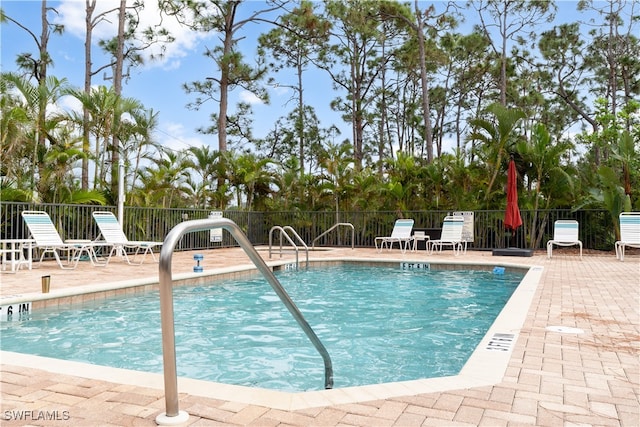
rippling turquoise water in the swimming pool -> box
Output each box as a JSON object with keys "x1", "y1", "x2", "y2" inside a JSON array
[{"x1": 0, "y1": 264, "x2": 523, "y2": 391}]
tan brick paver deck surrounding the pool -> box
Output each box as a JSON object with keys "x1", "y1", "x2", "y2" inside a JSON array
[{"x1": 0, "y1": 249, "x2": 640, "y2": 427}]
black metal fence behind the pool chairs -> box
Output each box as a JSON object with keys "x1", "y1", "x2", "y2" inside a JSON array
[{"x1": 0, "y1": 202, "x2": 616, "y2": 251}]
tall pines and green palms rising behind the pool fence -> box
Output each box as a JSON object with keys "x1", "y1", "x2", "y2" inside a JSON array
[{"x1": 0, "y1": 0, "x2": 640, "y2": 247}]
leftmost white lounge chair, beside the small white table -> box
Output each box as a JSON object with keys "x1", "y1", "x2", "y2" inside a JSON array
[{"x1": 22, "y1": 211, "x2": 109, "y2": 270}]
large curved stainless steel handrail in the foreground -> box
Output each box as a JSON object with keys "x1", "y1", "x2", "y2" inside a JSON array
[{"x1": 156, "y1": 218, "x2": 333, "y2": 425}]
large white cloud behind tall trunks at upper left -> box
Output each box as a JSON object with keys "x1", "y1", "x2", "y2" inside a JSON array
[{"x1": 55, "y1": 0, "x2": 215, "y2": 69}]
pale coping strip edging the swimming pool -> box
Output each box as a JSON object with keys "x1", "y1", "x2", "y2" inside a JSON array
[{"x1": 0, "y1": 257, "x2": 543, "y2": 410}]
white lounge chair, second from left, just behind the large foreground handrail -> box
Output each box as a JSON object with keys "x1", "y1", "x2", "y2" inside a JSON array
[{"x1": 93, "y1": 211, "x2": 163, "y2": 265}]
